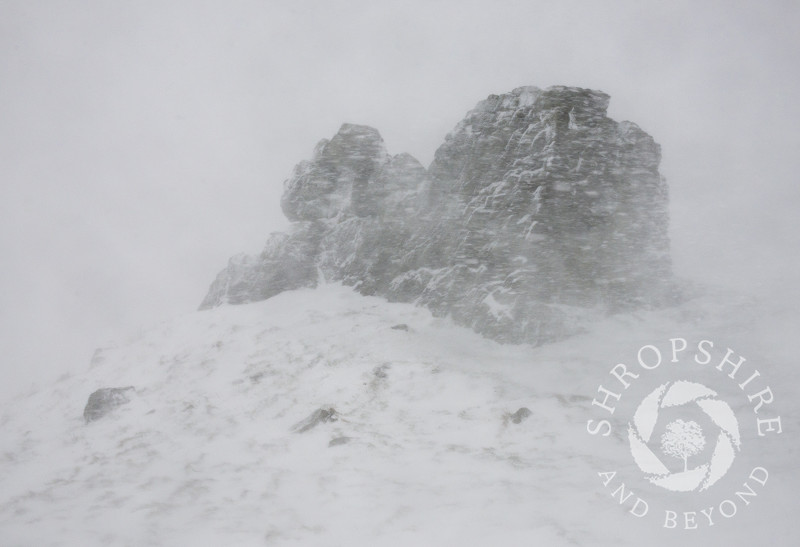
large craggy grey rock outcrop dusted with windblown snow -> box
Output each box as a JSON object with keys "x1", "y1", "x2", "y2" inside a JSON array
[{"x1": 201, "y1": 87, "x2": 671, "y2": 343}]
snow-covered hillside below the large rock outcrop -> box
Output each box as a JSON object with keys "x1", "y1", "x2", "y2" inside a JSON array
[{"x1": 0, "y1": 285, "x2": 800, "y2": 546}]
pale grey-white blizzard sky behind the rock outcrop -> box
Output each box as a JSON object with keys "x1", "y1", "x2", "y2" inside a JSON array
[{"x1": 0, "y1": 0, "x2": 800, "y2": 398}]
